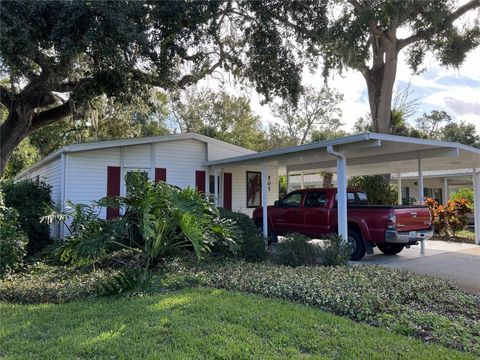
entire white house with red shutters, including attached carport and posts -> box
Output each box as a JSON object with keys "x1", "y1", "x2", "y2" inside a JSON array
[{"x1": 16, "y1": 133, "x2": 480, "y2": 245}]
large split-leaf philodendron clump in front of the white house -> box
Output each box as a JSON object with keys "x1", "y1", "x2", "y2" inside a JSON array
[{"x1": 44, "y1": 172, "x2": 238, "y2": 269}]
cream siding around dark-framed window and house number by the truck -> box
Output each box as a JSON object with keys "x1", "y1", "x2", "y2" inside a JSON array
[{"x1": 223, "y1": 166, "x2": 278, "y2": 216}]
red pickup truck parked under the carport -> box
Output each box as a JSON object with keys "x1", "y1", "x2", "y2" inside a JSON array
[{"x1": 253, "y1": 188, "x2": 433, "y2": 260}]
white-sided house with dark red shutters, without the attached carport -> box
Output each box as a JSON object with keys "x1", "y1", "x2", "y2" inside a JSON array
[{"x1": 15, "y1": 134, "x2": 278, "y2": 237}]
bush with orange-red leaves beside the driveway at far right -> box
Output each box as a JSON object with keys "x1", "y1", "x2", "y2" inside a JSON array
[{"x1": 425, "y1": 198, "x2": 473, "y2": 236}]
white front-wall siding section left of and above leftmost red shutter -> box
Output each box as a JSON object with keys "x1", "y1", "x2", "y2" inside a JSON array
[{"x1": 65, "y1": 148, "x2": 120, "y2": 218}]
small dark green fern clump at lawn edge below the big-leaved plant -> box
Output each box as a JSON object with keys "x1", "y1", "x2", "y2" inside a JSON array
[{"x1": 96, "y1": 268, "x2": 151, "y2": 296}]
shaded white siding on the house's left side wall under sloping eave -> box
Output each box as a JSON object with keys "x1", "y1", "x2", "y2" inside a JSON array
[{"x1": 19, "y1": 157, "x2": 62, "y2": 238}]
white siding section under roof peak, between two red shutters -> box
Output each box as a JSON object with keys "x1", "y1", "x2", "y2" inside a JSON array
[{"x1": 154, "y1": 140, "x2": 207, "y2": 188}]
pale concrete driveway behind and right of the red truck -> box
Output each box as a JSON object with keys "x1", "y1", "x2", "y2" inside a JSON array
[{"x1": 355, "y1": 240, "x2": 480, "y2": 294}]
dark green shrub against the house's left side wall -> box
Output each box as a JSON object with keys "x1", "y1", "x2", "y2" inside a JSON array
[{"x1": 0, "y1": 180, "x2": 52, "y2": 255}]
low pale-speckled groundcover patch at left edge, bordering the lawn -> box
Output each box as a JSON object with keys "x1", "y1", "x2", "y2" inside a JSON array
[{"x1": 0, "y1": 263, "x2": 118, "y2": 304}]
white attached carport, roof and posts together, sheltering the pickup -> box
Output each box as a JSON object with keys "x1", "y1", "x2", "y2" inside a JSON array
[{"x1": 206, "y1": 133, "x2": 480, "y2": 245}]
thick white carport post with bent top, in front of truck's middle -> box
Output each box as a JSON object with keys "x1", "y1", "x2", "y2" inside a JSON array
[{"x1": 327, "y1": 145, "x2": 348, "y2": 241}]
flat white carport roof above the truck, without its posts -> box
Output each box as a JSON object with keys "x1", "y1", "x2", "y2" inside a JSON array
[{"x1": 207, "y1": 133, "x2": 480, "y2": 176}]
